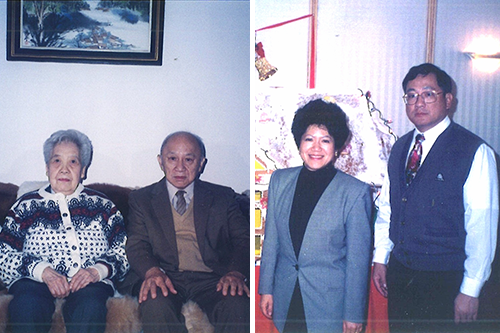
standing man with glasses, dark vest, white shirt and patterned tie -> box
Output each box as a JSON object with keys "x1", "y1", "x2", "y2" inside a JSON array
[{"x1": 373, "y1": 64, "x2": 498, "y2": 333}]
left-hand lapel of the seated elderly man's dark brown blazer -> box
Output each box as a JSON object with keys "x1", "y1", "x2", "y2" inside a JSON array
[{"x1": 151, "y1": 178, "x2": 178, "y2": 258}]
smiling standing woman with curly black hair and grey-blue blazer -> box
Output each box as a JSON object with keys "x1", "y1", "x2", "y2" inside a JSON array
[{"x1": 259, "y1": 99, "x2": 372, "y2": 333}]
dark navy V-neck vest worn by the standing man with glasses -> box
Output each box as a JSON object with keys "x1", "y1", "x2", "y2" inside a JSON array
[{"x1": 388, "y1": 122, "x2": 483, "y2": 271}]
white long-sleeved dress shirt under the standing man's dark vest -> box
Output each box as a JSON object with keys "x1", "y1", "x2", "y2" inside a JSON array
[{"x1": 373, "y1": 117, "x2": 498, "y2": 297}]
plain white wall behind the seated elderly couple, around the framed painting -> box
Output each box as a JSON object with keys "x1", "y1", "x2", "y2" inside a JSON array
[{"x1": 0, "y1": 0, "x2": 250, "y2": 192}]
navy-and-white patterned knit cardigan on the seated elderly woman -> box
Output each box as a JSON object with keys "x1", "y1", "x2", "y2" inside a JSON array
[{"x1": 0, "y1": 184, "x2": 129, "y2": 286}]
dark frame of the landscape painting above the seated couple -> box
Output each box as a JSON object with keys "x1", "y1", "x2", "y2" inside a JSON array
[{"x1": 7, "y1": 0, "x2": 165, "y2": 66}]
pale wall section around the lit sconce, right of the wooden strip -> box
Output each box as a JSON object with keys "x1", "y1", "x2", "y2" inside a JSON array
[{"x1": 436, "y1": 0, "x2": 500, "y2": 148}]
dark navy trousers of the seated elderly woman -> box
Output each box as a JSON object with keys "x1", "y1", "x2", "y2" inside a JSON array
[{"x1": 9, "y1": 279, "x2": 113, "y2": 333}]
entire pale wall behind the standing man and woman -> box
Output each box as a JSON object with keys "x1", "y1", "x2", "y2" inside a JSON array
[{"x1": 254, "y1": 0, "x2": 500, "y2": 152}]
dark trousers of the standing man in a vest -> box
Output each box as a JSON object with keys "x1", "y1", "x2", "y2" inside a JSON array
[{"x1": 387, "y1": 258, "x2": 468, "y2": 333}]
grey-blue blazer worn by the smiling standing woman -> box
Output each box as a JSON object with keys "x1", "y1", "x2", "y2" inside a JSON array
[{"x1": 259, "y1": 167, "x2": 372, "y2": 332}]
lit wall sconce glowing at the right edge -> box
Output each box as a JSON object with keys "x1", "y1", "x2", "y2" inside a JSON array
[{"x1": 464, "y1": 35, "x2": 500, "y2": 73}]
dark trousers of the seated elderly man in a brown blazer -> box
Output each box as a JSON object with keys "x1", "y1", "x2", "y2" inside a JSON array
[{"x1": 139, "y1": 272, "x2": 250, "y2": 333}]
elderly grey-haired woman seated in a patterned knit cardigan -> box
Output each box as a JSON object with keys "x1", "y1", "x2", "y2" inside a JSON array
[{"x1": 0, "y1": 130, "x2": 129, "y2": 333}]
